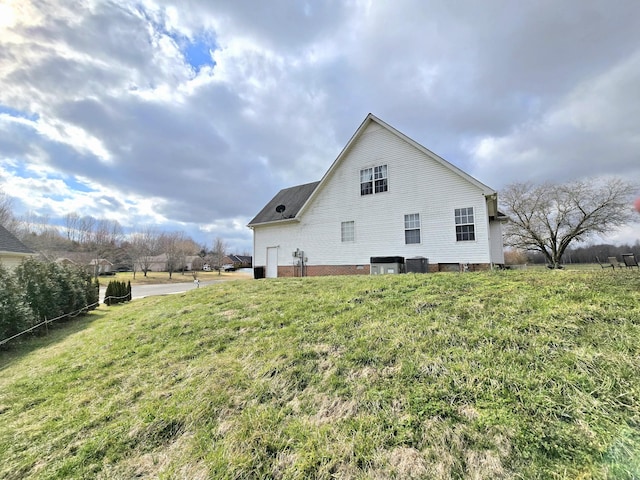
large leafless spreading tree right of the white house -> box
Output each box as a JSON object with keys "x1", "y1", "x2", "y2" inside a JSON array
[{"x1": 500, "y1": 178, "x2": 637, "y2": 268}]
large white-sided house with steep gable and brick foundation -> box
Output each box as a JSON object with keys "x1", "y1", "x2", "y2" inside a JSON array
[{"x1": 248, "y1": 114, "x2": 505, "y2": 277}]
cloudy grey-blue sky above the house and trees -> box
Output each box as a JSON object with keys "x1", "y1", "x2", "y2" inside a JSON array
[{"x1": 0, "y1": 0, "x2": 640, "y2": 253}]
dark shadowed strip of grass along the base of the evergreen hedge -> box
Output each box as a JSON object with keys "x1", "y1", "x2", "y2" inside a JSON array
[{"x1": 0, "y1": 309, "x2": 108, "y2": 371}]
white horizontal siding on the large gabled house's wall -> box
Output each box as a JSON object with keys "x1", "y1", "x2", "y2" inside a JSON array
[{"x1": 254, "y1": 122, "x2": 497, "y2": 265}]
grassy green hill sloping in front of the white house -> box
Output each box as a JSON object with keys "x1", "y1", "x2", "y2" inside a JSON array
[{"x1": 0, "y1": 271, "x2": 640, "y2": 479}]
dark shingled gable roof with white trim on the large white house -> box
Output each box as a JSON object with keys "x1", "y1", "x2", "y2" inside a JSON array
[{"x1": 248, "y1": 113, "x2": 497, "y2": 227}]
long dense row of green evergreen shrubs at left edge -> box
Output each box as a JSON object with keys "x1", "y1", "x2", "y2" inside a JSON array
[{"x1": 0, "y1": 258, "x2": 100, "y2": 340}]
